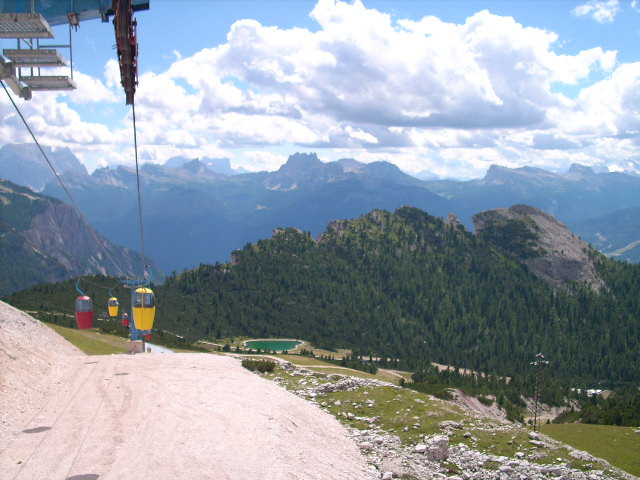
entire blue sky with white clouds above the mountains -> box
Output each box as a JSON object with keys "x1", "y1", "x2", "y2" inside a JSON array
[{"x1": 0, "y1": 0, "x2": 640, "y2": 180}]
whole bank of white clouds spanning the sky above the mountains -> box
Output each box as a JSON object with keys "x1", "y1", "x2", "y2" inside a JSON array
[{"x1": 0, "y1": 0, "x2": 640, "y2": 178}]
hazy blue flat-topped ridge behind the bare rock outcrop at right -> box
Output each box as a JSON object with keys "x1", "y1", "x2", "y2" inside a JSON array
[{"x1": 425, "y1": 164, "x2": 640, "y2": 263}]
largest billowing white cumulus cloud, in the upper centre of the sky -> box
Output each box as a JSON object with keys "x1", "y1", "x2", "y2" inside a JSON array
[{"x1": 149, "y1": 0, "x2": 616, "y2": 161}]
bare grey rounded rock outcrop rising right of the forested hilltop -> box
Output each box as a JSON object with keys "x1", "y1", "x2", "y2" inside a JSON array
[{"x1": 473, "y1": 205, "x2": 604, "y2": 291}]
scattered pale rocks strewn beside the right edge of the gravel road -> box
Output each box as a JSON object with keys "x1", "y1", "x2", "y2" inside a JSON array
[{"x1": 276, "y1": 364, "x2": 631, "y2": 480}]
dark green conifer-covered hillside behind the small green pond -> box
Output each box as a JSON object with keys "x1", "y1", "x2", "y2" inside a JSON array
[{"x1": 8, "y1": 207, "x2": 640, "y2": 383}]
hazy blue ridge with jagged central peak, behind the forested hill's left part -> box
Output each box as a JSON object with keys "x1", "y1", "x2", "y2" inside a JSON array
[{"x1": 44, "y1": 154, "x2": 447, "y2": 271}]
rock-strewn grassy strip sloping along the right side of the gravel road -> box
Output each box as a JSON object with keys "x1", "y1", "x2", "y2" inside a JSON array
[{"x1": 262, "y1": 363, "x2": 637, "y2": 480}]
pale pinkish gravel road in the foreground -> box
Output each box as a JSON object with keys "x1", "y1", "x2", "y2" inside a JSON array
[{"x1": 0, "y1": 304, "x2": 372, "y2": 480}]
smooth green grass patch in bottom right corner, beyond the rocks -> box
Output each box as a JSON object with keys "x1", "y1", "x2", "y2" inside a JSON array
[{"x1": 541, "y1": 423, "x2": 640, "y2": 476}]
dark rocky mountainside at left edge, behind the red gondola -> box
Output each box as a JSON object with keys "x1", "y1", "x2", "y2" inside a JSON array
[{"x1": 0, "y1": 180, "x2": 160, "y2": 295}]
